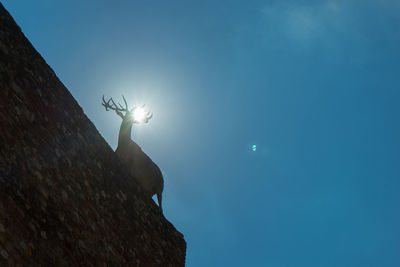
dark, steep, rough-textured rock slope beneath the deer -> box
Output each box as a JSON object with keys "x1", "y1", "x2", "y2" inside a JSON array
[{"x1": 0, "y1": 4, "x2": 186, "y2": 266}]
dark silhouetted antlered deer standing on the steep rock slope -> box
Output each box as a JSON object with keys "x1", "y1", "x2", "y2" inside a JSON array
[{"x1": 102, "y1": 96, "x2": 164, "y2": 212}]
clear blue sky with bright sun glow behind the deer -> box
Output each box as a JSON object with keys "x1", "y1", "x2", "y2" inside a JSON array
[{"x1": 1, "y1": 0, "x2": 400, "y2": 267}]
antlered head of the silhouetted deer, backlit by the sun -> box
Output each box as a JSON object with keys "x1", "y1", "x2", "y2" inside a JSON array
[{"x1": 101, "y1": 95, "x2": 153, "y2": 124}]
